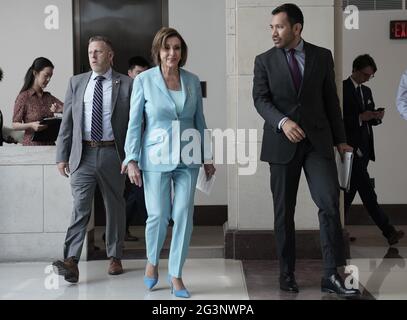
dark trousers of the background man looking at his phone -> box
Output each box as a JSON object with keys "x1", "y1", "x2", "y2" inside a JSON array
[{"x1": 345, "y1": 156, "x2": 394, "y2": 238}]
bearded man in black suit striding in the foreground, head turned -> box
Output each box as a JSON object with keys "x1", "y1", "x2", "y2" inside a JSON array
[{"x1": 253, "y1": 4, "x2": 360, "y2": 295}]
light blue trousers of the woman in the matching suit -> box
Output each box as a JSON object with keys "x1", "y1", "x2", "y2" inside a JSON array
[{"x1": 143, "y1": 165, "x2": 199, "y2": 278}]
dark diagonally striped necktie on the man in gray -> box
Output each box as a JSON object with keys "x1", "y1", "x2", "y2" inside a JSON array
[{"x1": 90, "y1": 76, "x2": 105, "y2": 141}]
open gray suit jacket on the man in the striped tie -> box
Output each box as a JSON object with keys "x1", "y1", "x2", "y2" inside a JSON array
[{"x1": 56, "y1": 70, "x2": 133, "y2": 173}]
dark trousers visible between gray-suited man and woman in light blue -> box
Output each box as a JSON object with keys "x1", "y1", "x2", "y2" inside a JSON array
[{"x1": 124, "y1": 179, "x2": 147, "y2": 231}]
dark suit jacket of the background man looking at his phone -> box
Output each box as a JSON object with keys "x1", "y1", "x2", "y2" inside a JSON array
[{"x1": 343, "y1": 78, "x2": 381, "y2": 161}]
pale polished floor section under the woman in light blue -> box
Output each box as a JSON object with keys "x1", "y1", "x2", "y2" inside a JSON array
[{"x1": 0, "y1": 259, "x2": 249, "y2": 300}]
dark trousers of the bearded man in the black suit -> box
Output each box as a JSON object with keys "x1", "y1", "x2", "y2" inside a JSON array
[{"x1": 270, "y1": 139, "x2": 346, "y2": 273}]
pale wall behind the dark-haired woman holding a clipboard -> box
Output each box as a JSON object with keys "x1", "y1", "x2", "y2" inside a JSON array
[{"x1": 0, "y1": 0, "x2": 73, "y2": 126}]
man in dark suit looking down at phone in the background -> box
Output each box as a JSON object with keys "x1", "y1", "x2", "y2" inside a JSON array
[{"x1": 343, "y1": 54, "x2": 404, "y2": 245}]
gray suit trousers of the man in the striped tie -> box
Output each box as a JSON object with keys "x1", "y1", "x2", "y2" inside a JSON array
[{"x1": 64, "y1": 146, "x2": 126, "y2": 260}]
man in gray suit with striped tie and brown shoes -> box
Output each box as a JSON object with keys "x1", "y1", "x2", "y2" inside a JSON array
[{"x1": 53, "y1": 36, "x2": 132, "y2": 282}]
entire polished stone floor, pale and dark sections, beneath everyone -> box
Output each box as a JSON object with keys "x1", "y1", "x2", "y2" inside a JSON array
[{"x1": 0, "y1": 226, "x2": 407, "y2": 300}]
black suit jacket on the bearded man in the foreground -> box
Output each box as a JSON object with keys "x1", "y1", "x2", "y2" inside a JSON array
[{"x1": 253, "y1": 42, "x2": 346, "y2": 164}]
